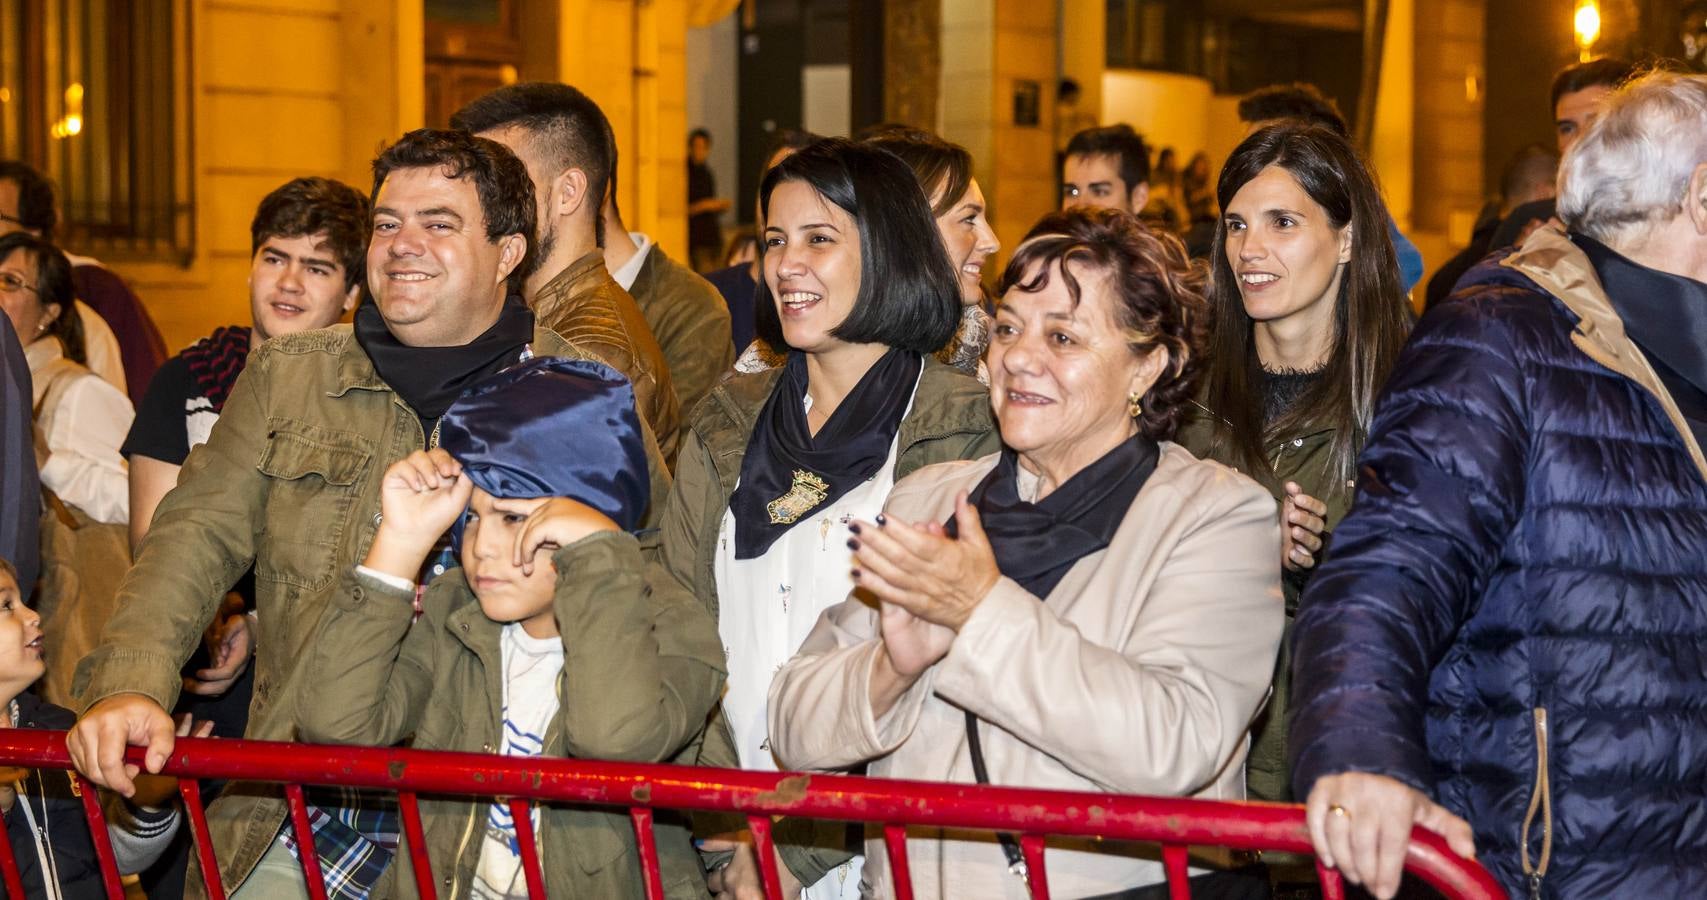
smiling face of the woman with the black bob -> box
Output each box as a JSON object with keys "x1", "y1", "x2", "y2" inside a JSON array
[{"x1": 765, "y1": 181, "x2": 860, "y2": 354}]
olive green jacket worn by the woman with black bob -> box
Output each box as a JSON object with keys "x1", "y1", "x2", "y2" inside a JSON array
[{"x1": 647, "y1": 357, "x2": 1002, "y2": 885}]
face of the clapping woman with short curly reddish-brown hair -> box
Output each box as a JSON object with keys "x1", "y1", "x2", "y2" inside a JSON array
[{"x1": 987, "y1": 263, "x2": 1168, "y2": 476}]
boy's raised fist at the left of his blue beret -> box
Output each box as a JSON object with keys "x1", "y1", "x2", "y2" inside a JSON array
[{"x1": 362, "y1": 447, "x2": 475, "y2": 581}]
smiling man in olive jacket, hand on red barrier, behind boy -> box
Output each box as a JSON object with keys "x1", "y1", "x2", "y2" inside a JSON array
[{"x1": 67, "y1": 130, "x2": 669, "y2": 898}]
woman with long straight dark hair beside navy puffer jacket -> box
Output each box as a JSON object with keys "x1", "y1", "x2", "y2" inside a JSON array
[{"x1": 1180, "y1": 123, "x2": 1410, "y2": 801}]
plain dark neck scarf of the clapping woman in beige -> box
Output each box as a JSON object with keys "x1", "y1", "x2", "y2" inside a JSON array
[{"x1": 944, "y1": 434, "x2": 1161, "y2": 599}]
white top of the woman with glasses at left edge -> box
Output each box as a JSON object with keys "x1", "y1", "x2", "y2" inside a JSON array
[{"x1": 24, "y1": 338, "x2": 137, "y2": 524}]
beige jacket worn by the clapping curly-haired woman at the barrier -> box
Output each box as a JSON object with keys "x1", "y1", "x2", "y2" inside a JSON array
[{"x1": 770, "y1": 444, "x2": 1284, "y2": 898}]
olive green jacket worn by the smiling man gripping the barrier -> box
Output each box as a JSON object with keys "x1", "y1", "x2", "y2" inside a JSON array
[{"x1": 73, "y1": 324, "x2": 669, "y2": 895}]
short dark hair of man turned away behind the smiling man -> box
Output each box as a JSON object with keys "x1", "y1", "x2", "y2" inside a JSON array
[{"x1": 451, "y1": 82, "x2": 616, "y2": 248}]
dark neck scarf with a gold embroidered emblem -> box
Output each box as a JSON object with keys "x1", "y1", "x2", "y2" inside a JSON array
[{"x1": 729, "y1": 350, "x2": 923, "y2": 560}]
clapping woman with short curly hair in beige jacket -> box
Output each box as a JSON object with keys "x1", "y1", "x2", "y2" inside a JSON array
[{"x1": 770, "y1": 210, "x2": 1282, "y2": 898}]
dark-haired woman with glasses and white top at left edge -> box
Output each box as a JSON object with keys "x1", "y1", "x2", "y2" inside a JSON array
[{"x1": 0, "y1": 232, "x2": 133, "y2": 524}]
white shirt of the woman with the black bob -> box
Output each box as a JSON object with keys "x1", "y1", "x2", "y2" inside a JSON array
[{"x1": 717, "y1": 381, "x2": 918, "y2": 900}]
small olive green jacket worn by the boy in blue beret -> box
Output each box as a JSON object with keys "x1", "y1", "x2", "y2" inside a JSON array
[{"x1": 299, "y1": 531, "x2": 724, "y2": 898}]
